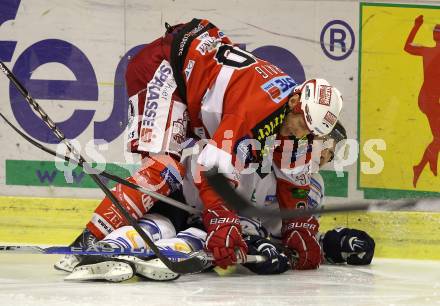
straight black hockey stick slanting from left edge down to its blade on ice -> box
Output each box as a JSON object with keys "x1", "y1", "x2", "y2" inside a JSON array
[{"x1": 0, "y1": 61, "x2": 204, "y2": 274}]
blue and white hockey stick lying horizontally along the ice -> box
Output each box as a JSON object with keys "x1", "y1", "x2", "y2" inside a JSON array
[{"x1": 0, "y1": 245, "x2": 266, "y2": 263}]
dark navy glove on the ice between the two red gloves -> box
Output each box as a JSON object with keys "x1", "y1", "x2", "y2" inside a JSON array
[{"x1": 244, "y1": 235, "x2": 290, "y2": 274}]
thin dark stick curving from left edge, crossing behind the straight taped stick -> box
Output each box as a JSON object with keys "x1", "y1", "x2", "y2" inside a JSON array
[{"x1": 0, "y1": 113, "x2": 200, "y2": 214}]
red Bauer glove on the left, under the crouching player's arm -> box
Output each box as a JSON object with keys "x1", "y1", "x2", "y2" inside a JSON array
[{"x1": 203, "y1": 206, "x2": 247, "y2": 269}]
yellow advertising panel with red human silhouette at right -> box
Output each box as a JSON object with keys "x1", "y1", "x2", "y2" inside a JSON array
[{"x1": 359, "y1": 3, "x2": 440, "y2": 197}]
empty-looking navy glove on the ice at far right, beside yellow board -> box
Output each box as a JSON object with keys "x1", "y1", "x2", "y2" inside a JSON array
[{"x1": 322, "y1": 227, "x2": 375, "y2": 265}]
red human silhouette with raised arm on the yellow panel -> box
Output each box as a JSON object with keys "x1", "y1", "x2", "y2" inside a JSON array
[{"x1": 405, "y1": 15, "x2": 440, "y2": 187}]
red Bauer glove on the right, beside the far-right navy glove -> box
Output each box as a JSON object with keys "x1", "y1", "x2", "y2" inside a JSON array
[{"x1": 282, "y1": 216, "x2": 321, "y2": 270}]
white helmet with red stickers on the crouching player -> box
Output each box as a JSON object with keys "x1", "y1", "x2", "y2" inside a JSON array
[{"x1": 295, "y1": 79, "x2": 342, "y2": 136}]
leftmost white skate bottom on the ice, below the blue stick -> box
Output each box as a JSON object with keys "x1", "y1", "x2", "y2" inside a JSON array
[{"x1": 64, "y1": 261, "x2": 133, "y2": 282}]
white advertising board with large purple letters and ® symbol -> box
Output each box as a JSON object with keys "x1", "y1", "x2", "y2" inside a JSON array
[{"x1": 0, "y1": 0, "x2": 358, "y2": 197}]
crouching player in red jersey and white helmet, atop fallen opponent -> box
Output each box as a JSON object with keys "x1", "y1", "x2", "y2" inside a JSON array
[{"x1": 61, "y1": 19, "x2": 342, "y2": 269}]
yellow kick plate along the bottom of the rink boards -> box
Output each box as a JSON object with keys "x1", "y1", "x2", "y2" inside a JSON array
[{"x1": 0, "y1": 197, "x2": 440, "y2": 260}]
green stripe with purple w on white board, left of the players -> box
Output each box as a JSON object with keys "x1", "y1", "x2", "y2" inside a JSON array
[{"x1": 6, "y1": 160, "x2": 134, "y2": 188}]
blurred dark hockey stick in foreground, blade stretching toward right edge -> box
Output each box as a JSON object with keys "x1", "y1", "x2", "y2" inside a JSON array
[{"x1": 205, "y1": 168, "x2": 420, "y2": 219}]
